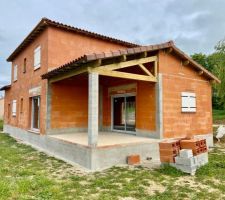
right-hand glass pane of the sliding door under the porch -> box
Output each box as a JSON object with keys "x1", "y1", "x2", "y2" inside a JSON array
[{"x1": 126, "y1": 96, "x2": 136, "y2": 131}]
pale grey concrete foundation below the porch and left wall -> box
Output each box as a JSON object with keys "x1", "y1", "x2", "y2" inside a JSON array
[{"x1": 4, "y1": 125, "x2": 162, "y2": 171}]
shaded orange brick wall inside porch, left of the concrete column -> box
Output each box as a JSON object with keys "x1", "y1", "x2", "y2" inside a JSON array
[{"x1": 51, "y1": 79, "x2": 88, "y2": 129}]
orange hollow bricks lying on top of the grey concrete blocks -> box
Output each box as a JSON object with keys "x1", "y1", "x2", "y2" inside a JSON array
[{"x1": 180, "y1": 139, "x2": 207, "y2": 156}]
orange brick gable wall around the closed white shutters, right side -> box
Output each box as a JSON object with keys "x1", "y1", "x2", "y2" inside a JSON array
[{"x1": 159, "y1": 52, "x2": 212, "y2": 138}]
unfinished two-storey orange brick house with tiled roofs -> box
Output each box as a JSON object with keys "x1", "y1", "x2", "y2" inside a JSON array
[{"x1": 2, "y1": 18, "x2": 220, "y2": 169}]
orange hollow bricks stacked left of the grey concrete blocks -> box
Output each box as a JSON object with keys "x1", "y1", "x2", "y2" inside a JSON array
[{"x1": 159, "y1": 140, "x2": 180, "y2": 163}]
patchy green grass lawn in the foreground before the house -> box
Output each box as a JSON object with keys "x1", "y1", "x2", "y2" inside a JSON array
[{"x1": 0, "y1": 133, "x2": 225, "y2": 200}]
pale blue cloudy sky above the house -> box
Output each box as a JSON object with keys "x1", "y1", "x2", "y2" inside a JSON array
[{"x1": 0, "y1": 0, "x2": 225, "y2": 93}]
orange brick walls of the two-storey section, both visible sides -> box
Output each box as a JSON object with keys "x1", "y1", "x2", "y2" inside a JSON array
[{"x1": 4, "y1": 25, "x2": 128, "y2": 134}]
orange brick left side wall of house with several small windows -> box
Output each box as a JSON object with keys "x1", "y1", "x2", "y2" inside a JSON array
[{"x1": 4, "y1": 30, "x2": 48, "y2": 132}]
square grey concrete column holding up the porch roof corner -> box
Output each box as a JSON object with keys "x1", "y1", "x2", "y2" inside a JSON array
[{"x1": 88, "y1": 73, "x2": 99, "y2": 147}]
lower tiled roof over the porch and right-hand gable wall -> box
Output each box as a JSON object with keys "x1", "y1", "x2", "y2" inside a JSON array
[{"x1": 42, "y1": 41, "x2": 220, "y2": 83}]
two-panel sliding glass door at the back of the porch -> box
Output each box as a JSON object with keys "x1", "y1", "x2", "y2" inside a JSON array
[{"x1": 112, "y1": 94, "x2": 136, "y2": 133}]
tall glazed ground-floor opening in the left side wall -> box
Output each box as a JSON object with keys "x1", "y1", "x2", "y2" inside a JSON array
[{"x1": 31, "y1": 96, "x2": 40, "y2": 131}]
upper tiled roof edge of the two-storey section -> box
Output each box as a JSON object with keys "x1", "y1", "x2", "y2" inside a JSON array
[{"x1": 7, "y1": 18, "x2": 138, "y2": 61}]
